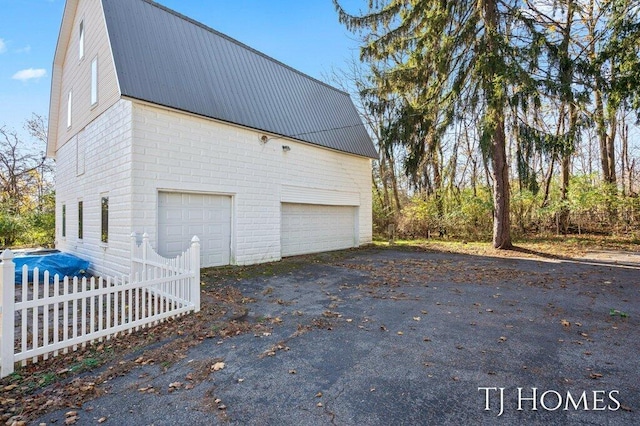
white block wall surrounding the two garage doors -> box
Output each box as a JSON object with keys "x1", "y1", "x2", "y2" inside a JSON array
[{"x1": 132, "y1": 102, "x2": 372, "y2": 264}]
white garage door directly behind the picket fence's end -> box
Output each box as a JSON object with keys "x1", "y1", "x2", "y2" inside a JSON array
[{"x1": 158, "y1": 192, "x2": 231, "y2": 267}]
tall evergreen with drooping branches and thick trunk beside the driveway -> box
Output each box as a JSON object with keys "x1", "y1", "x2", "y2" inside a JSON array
[{"x1": 333, "y1": 0, "x2": 535, "y2": 249}]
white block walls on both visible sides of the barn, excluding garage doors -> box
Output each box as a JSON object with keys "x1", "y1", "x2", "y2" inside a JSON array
[{"x1": 56, "y1": 100, "x2": 372, "y2": 274}]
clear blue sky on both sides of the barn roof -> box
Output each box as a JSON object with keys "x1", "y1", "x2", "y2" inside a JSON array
[{"x1": 0, "y1": 0, "x2": 366, "y2": 138}]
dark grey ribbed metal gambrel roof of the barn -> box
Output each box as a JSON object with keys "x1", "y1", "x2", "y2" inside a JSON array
[{"x1": 102, "y1": 0, "x2": 377, "y2": 158}]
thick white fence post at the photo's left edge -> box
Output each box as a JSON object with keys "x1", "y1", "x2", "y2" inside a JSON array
[{"x1": 0, "y1": 249, "x2": 15, "y2": 378}]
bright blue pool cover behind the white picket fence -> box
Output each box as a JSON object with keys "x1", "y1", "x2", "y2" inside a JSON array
[{"x1": 13, "y1": 250, "x2": 89, "y2": 284}]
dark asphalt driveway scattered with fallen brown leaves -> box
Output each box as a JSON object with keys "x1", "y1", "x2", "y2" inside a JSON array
[{"x1": 27, "y1": 249, "x2": 640, "y2": 425}]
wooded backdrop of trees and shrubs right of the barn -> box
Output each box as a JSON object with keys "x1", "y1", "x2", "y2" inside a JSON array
[{"x1": 334, "y1": 0, "x2": 640, "y2": 248}]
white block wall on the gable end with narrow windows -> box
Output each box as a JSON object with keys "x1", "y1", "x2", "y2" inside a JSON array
[{"x1": 56, "y1": 98, "x2": 132, "y2": 274}]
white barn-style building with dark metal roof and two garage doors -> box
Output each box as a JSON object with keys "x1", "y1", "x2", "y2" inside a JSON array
[{"x1": 47, "y1": 0, "x2": 376, "y2": 274}]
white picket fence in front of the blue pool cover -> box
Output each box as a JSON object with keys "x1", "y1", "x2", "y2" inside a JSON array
[{"x1": 0, "y1": 234, "x2": 200, "y2": 378}]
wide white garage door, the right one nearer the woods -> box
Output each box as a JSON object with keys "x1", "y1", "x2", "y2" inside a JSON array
[{"x1": 281, "y1": 203, "x2": 358, "y2": 256}]
